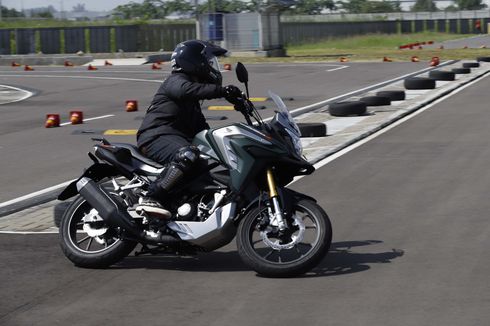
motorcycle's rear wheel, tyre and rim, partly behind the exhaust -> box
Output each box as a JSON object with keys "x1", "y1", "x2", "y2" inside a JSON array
[{"x1": 59, "y1": 196, "x2": 137, "y2": 268}]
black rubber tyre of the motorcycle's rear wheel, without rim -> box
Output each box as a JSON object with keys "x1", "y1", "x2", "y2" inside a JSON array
[{"x1": 59, "y1": 196, "x2": 137, "y2": 268}]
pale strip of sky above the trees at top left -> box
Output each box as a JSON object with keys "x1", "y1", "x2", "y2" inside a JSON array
[{"x1": 0, "y1": 0, "x2": 143, "y2": 11}]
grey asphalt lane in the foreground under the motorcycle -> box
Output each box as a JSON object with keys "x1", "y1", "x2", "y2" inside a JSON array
[{"x1": 0, "y1": 62, "x2": 490, "y2": 325}]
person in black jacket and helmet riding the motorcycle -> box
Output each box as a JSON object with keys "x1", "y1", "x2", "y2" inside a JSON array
[{"x1": 136, "y1": 40, "x2": 241, "y2": 219}]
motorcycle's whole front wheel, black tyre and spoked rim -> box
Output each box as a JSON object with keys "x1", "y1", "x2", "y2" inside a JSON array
[{"x1": 237, "y1": 199, "x2": 332, "y2": 277}]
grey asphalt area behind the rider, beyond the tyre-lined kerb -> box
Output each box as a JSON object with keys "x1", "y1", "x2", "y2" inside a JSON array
[{"x1": 0, "y1": 63, "x2": 427, "y2": 203}]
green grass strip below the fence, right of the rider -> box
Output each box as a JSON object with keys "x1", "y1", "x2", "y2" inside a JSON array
[{"x1": 223, "y1": 32, "x2": 490, "y2": 63}]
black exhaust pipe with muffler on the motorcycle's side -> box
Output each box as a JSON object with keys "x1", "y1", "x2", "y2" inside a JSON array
[{"x1": 77, "y1": 177, "x2": 181, "y2": 244}]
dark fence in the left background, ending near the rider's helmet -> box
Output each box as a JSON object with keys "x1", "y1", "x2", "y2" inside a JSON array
[{"x1": 0, "y1": 24, "x2": 196, "y2": 55}]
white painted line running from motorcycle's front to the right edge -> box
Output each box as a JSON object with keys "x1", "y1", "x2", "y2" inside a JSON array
[{"x1": 291, "y1": 69, "x2": 490, "y2": 178}]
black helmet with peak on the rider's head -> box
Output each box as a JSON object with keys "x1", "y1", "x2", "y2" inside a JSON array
[{"x1": 171, "y1": 40, "x2": 227, "y2": 85}]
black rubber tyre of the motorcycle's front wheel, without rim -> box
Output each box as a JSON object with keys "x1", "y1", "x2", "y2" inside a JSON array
[{"x1": 237, "y1": 199, "x2": 332, "y2": 277}]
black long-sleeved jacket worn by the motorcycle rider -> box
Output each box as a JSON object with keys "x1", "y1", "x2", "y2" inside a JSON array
[{"x1": 136, "y1": 73, "x2": 223, "y2": 148}]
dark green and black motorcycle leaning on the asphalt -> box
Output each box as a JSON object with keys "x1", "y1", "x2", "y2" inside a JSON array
[{"x1": 58, "y1": 63, "x2": 332, "y2": 277}]
